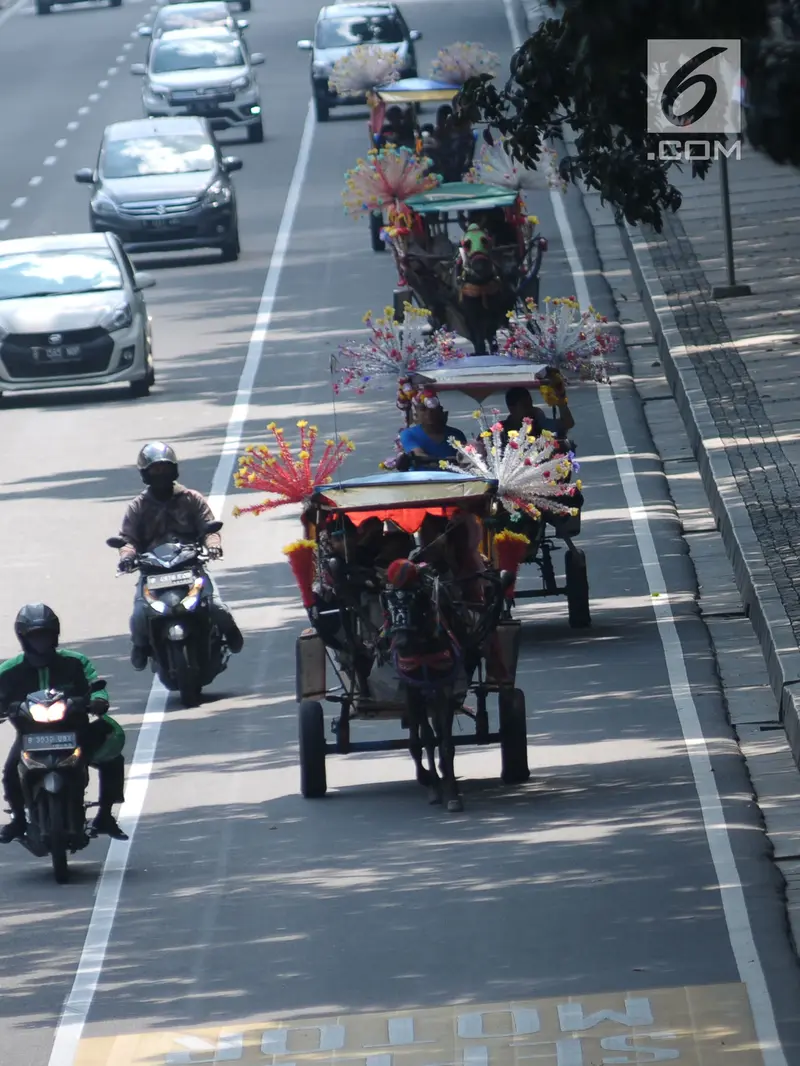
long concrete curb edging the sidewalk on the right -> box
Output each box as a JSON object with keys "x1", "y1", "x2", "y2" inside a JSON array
[{"x1": 619, "y1": 224, "x2": 800, "y2": 765}]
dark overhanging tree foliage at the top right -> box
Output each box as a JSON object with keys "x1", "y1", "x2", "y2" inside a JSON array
[{"x1": 460, "y1": 0, "x2": 785, "y2": 230}]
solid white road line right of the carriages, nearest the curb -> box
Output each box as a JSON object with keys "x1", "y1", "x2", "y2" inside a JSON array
[{"x1": 550, "y1": 98, "x2": 787, "y2": 1066}]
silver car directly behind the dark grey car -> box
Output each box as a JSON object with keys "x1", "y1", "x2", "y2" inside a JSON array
[{"x1": 130, "y1": 26, "x2": 263, "y2": 143}]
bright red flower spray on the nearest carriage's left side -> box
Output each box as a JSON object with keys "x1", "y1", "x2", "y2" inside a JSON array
[{"x1": 234, "y1": 419, "x2": 355, "y2": 518}]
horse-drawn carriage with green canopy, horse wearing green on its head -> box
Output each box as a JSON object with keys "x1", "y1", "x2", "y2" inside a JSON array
[{"x1": 387, "y1": 181, "x2": 547, "y2": 354}]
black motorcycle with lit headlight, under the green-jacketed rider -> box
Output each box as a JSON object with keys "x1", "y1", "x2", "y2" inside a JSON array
[{"x1": 9, "y1": 679, "x2": 106, "y2": 885}]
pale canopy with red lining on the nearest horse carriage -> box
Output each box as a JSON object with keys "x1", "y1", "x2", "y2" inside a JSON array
[{"x1": 309, "y1": 470, "x2": 497, "y2": 533}]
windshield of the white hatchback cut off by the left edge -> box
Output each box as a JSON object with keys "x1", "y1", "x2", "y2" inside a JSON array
[{"x1": 0, "y1": 248, "x2": 123, "y2": 300}]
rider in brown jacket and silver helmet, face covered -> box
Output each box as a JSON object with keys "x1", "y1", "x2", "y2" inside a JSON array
[{"x1": 119, "y1": 440, "x2": 244, "y2": 671}]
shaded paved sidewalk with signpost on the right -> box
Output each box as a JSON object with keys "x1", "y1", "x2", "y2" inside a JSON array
[{"x1": 622, "y1": 146, "x2": 800, "y2": 763}]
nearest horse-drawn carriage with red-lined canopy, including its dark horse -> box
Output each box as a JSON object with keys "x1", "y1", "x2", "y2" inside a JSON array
[{"x1": 297, "y1": 471, "x2": 529, "y2": 810}]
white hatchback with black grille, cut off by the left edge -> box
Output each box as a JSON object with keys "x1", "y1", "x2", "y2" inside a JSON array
[{"x1": 0, "y1": 233, "x2": 156, "y2": 397}]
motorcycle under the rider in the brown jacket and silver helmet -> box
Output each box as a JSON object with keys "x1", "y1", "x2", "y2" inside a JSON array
[{"x1": 106, "y1": 522, "x2": 230, "y2": 707}]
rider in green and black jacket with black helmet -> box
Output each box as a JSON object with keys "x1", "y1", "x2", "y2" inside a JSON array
[{"x1": 0, "y1": 603, "x2": 128, "y2": 844}]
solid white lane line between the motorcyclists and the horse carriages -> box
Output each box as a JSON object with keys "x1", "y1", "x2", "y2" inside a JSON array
[{"x1": 48, "y1": 103, "x2": 316, "y2": 1066}]
